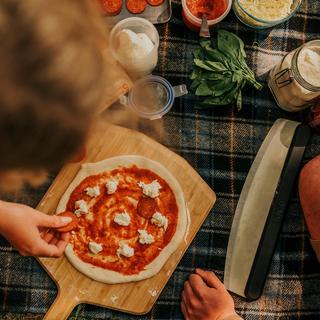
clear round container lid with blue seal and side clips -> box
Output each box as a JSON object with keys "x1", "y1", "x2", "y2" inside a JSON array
[{"x1": 120, "y1": 76, "x2": 188, "y2": 120}]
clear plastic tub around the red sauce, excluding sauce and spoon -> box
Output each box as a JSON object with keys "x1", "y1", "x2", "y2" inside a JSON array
[{"x1": 181, "y1": 0, "x2": 232, "y2": 32}]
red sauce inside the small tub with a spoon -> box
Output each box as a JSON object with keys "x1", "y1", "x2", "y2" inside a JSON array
[{"x1": 186, "y1": 0, "x2": 227, "y2": 20}]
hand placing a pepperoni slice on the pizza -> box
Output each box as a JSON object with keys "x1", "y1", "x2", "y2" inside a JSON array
[{"x1": 0, "y1": 201, "x2": 72, "y2": 257}]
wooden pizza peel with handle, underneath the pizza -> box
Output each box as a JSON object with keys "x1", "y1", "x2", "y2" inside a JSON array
[{"x1": 37, "y1": 123, "x2": 216, "y2": 320}]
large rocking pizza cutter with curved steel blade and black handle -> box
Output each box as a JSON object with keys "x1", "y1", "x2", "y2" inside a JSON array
[{"x1": 224, "y1": 119, "x2": 310, "y2": 300}]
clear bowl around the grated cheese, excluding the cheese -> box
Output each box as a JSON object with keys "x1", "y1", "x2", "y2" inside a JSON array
[{"x1": 232, "y1": 0, "x2": 302, "y2": 29}]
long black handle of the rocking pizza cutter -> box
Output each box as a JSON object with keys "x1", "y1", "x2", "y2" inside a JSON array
[{"x1": 244, "y1": 125, "x2": 311, "y2": 300}]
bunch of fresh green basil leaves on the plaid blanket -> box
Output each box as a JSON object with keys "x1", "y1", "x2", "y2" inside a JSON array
[{"x1": 190, "y1": 30, "x2": 262, "y2": 110}]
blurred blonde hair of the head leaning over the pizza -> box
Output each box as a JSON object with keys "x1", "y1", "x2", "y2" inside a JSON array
[{"x1": 0, "y1": 0, "x2": 106, "y2": 189}]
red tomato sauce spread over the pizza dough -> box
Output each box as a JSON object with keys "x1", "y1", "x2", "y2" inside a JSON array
[{"x1": 67, "y1": 166, "x2": 178, "y2": 275}]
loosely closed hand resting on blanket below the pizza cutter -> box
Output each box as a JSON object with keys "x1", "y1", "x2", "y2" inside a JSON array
[{"x1": 181, "y1": 269, "x2": 236, "y2": 320}]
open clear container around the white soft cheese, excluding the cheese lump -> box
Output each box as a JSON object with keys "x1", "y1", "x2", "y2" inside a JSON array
[{"x1": 109, "y1": 17, "x2": 159, "y2": 78}]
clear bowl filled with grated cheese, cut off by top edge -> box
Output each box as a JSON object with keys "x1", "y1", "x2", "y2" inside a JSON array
[{"x1": 232, "y1": 0, "x2": 302, "y2": 29}]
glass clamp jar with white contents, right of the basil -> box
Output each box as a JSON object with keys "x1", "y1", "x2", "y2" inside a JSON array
[{"x1": 268, "y1": 40, "x2": 320, "y2": 112}]
